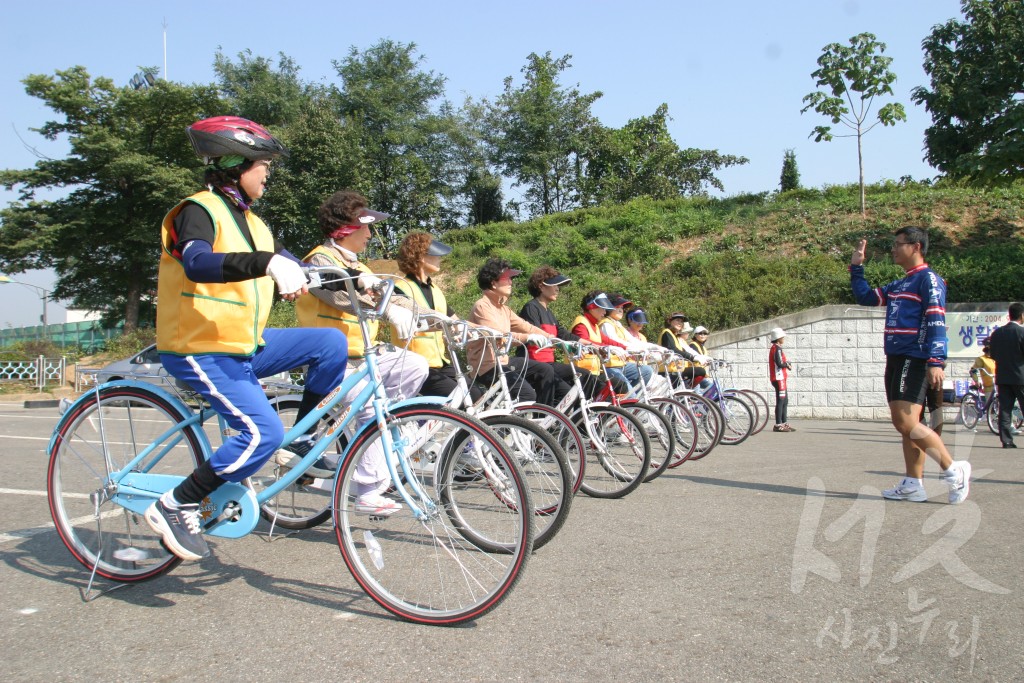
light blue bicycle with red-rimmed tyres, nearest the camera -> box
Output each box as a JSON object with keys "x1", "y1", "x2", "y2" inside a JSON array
[{"x1": 47, "y1": 267, "x2": 534, "y2": 625}]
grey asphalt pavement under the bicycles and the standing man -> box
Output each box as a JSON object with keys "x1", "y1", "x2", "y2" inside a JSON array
[{"x1": 0, "y1": 403, "x2": 1024, "y2": 683}]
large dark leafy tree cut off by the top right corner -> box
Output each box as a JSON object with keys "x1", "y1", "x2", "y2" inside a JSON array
[{"x1": 911, "y1": 0, "x2": 1024, "y2": 182}]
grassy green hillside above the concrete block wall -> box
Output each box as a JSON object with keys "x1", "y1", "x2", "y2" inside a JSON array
[{"x1": 428, "y1": 182, "x2": 1024, "y2": 330}]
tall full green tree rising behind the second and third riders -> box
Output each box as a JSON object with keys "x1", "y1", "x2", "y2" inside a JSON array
[{"x1": 333, "y1": 40, "x2": 468, "y2": 248}]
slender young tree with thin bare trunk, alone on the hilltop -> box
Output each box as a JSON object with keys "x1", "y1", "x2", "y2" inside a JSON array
[{"x1": 800, "y1": 33, "x2": 906, "y2": 215}]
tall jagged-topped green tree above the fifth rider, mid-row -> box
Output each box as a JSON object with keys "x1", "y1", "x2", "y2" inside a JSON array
[{"x1": 484, "y1": 52, "x2": 601, "y2": 214}]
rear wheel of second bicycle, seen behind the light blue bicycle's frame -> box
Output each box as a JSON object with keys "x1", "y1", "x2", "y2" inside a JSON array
[{"x1": 248, "y1": 394, "x2": 341, "y2": 529}]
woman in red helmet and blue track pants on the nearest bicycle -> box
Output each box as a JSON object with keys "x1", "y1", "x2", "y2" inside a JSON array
[{"x1": 145, "y1": 117, "x2": 347, "y2": 560}]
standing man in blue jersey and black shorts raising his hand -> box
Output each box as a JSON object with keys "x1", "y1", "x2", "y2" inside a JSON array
[{"x1": 850, "y1": 226, "x2": 971, "y2": 504}]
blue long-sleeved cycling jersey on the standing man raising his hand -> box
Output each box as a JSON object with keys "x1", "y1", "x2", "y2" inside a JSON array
[{"x1": 850, "y1": 263, "x2": 946, "y2": 368}]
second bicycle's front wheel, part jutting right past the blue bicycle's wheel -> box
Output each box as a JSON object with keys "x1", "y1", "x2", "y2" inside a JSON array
[{"x1": 483, "y1": 415, "x2": 573, "y2": 550}]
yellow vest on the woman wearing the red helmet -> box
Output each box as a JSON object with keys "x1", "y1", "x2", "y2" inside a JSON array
[{"x1": 157, "y1": 190, "x2": 273, "y2": 356}]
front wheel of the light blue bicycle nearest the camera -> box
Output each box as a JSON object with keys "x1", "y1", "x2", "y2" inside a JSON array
[{"x1": 334, "y1": 405, "x2": 535, "y2": 625}]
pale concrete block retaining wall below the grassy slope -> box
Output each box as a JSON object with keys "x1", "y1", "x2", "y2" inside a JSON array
[{"x1": 704, "y1": 302, "x2": 1009, "y2": 420}]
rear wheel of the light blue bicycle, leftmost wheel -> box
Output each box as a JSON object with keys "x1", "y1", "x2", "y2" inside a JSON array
[{"x1": 46, "y1": 385, "x2": 203, "y2": 583}]
